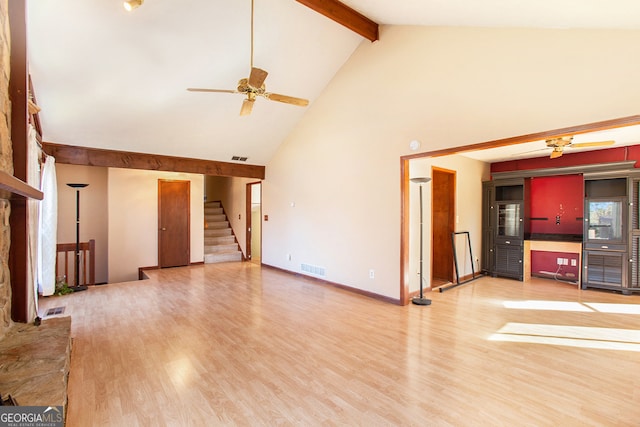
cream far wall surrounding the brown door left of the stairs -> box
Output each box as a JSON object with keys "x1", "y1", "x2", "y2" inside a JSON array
[{"x1": 108, "y1": 168, "x2": 204, "y2": 283}]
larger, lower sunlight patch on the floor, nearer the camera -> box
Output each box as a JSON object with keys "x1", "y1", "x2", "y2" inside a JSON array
[{"x1": 489, "y1": 323, "x2": 640, "y2": 352}]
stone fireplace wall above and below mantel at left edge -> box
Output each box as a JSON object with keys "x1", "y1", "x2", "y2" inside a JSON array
[{"x1": 0, "y1": 0, "x2": 13, "y2": 338}]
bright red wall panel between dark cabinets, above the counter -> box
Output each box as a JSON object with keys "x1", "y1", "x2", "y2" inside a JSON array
[{"x1": 530, "y1": 175, "x2": 584, "y2": 235}]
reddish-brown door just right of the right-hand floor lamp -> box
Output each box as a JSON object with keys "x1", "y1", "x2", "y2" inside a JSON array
[{"x1": 431, "y1": 167, "x2": 456, "y2": 288}]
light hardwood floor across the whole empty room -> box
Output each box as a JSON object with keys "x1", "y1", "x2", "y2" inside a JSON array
[{"x1": 41, "y1": 262, "x2": 640, "y2": 427}]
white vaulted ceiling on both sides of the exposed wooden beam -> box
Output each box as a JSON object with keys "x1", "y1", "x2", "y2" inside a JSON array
[{"x1": 28, "y1": 0, "x2": 640, "y2": 164}]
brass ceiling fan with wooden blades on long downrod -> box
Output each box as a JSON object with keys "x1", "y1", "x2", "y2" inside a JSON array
[{"x1": 187, "y1": 0, "x2": 309, "y2": 116}]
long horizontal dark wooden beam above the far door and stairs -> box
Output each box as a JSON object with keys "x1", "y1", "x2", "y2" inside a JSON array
[{"x1": 42, "y1": 142, "x2": 265, "y2": 179}]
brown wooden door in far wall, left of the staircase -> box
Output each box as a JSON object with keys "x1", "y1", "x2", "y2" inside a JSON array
[{"x1": 158, "y1": 179, "x2": 191, "y2": 268}]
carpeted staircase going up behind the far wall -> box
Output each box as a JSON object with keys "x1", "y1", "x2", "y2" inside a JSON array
[{"x1": 204, "y1": 202, "x2": 243, "y2": 264}]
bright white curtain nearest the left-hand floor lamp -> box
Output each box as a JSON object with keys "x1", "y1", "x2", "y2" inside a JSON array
[{"x1": 37, "y1": 156, "x2": 58, "y2": 296}]
